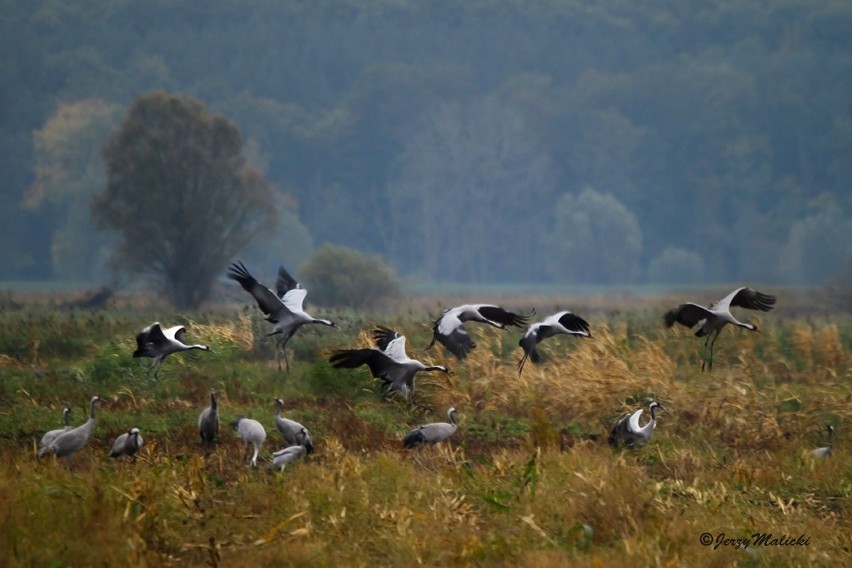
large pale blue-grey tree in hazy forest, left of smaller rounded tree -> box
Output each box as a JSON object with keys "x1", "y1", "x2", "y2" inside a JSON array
[{"x1": 388, "y1": 97, "x2": 553, "y2": 282}]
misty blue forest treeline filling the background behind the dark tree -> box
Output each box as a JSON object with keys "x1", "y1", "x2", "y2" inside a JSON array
[{"x1": 0, "y1": 0, "x2": 852, "y2": 283}]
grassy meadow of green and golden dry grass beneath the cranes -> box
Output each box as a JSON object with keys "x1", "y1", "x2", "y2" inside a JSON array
[{"x1": 0, "y1": 292, "x2": 852, "y2": 568}]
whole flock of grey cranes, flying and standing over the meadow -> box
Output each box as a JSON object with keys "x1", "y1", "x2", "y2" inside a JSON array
[{"x1": 38, "y1": 262, "x2": 834, "y2": 469}]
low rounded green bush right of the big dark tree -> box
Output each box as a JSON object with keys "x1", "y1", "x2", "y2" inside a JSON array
[{"x1": 300, "y1": 245, "x2": 402, "y2": 308}]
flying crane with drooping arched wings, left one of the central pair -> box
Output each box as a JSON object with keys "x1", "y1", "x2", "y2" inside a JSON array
[{"x1": 427, "y1": 304, "x2": 534, "y2": 359}]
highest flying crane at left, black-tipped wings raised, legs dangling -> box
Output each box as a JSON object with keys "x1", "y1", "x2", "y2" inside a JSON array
[{"x1": 228, "y1": 262, "x2": 337, "y2": 369}]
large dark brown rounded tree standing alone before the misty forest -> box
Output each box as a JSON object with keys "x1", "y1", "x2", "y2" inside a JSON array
[{"x1": 92, "y1": 92, "x2": 276, "y2": 308}]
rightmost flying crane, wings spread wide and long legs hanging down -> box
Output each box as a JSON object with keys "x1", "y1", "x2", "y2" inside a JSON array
[{"x1": 663, "y1": 286, "x2": 776, "y2": 371}]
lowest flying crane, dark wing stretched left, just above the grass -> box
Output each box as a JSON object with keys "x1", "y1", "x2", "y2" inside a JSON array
[{"x1": 329, "y1": 328, "x2": 450, "y2": 396}]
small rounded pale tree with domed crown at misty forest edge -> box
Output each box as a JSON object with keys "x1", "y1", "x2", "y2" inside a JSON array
[{"x1": 549, "y1": 187, "x2": 642, "y2": 284}]
